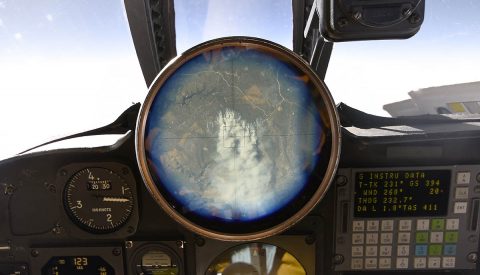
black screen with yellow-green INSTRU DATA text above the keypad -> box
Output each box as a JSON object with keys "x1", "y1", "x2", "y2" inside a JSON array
[{"x1": 354, "y1": 170, "x2": 451, "y2": 218}]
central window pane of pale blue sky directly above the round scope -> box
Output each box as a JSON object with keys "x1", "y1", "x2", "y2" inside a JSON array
[{"x1": 175, "y1": 0, "x2": 293, "y2": 53}]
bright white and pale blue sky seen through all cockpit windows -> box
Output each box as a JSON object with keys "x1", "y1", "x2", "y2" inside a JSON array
[{"x1": 0, "y1": 0, "x2": 480, "y2": 159}]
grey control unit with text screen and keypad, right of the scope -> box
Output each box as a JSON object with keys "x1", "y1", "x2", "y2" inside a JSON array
[{"x1": 335, "y1": 165, "x2": 480, "y2": 270}]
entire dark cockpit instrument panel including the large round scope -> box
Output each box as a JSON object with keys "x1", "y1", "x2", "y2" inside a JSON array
[{"x1": 0, "y1": 37, "x2": 480, "y2": 275}]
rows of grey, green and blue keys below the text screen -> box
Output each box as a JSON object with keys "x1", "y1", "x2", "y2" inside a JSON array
[{"x1": 351, "y1": 218, "x2": 460, "y2": 270}]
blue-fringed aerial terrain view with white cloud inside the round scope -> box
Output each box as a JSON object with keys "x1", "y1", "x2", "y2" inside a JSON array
[{"x1": 145, "y1": 46, "x2": 324, "y2": 222}]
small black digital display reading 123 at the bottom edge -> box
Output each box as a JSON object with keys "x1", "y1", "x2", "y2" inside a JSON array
[{"x1": 42, "y1": 256, "x2": 115, "y2": 275}]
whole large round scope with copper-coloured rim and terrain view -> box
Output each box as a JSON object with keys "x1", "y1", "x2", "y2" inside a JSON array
[{"x1": 137, "y1": 37, "x2": 339, "y2": 240}]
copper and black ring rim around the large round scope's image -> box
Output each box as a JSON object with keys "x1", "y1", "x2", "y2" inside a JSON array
[{"x1": 135, "y1": 37, "x2": 340, "y2": 241}]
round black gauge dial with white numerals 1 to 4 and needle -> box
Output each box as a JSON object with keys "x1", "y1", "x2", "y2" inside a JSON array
[{"x1": 64, "y1": 167, "x2": 134, "y2": 233}]
